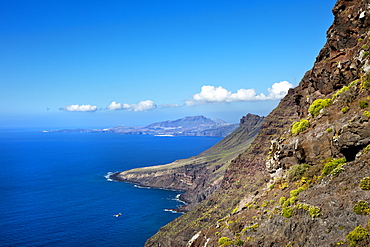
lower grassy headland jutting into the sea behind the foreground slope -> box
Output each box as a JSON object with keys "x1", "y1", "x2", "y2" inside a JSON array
[{"x1": 111, "y1": 114, "x2": 265, "y2": 211}]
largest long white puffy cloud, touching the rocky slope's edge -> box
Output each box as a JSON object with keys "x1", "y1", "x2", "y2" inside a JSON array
[{"x1": 185, "y1": 81, "x2": 293, "y2": 106}]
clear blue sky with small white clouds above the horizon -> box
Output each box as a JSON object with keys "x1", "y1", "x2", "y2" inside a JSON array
[{"x1": 0, "y1": 0, "x2": 335, "y2": 129}]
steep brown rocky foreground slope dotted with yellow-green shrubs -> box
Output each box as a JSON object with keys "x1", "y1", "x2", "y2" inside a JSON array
[{"x1": 146, "y1": 0, "x2": 370, "y2": 247}]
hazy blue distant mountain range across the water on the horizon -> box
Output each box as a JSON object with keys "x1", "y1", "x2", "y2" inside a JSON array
[{"x1": 44, "y1": 116, "x2": 239, "y2": 137}]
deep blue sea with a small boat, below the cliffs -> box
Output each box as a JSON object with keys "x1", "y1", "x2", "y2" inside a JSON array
[{"x1": 0, "y1": 131, "x2": 220, "y2": 247}]
